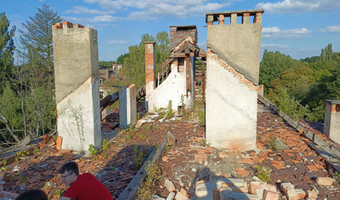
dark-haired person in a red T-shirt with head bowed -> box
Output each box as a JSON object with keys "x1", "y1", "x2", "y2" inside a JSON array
[{"x1": 59, "y1": 162, "x2": 113, "y2": 200}]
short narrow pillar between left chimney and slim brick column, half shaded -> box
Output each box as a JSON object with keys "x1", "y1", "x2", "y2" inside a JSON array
[{"x1": 119, "y1": 84, "x2": 137, "y2": 128}]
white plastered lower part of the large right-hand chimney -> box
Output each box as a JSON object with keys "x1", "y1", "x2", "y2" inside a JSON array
[{"x1": 206, "y1": 50, "x2": 257, "y2": 151}]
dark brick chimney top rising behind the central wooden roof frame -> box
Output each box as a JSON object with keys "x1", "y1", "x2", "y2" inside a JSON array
[{"x1": 170, "y1": 25, "x2": 197, "y2": 49}]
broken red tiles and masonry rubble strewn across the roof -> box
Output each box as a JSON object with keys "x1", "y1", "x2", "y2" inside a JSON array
[{"x1": 3, "y1": 101, "x2": 340, "y2": 199}]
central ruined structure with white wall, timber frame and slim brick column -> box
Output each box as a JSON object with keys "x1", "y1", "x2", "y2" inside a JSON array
[{"x1": 145, "y1": 25, "x2": 206, "y2": 112}]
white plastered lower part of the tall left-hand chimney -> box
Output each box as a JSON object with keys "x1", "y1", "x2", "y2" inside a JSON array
[{"x1": 57, "y1": 78, "x2": 101, "y2": 151}]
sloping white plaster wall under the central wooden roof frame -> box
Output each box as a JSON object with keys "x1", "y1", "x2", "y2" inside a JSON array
[{"x1": 148, "y1": 61, "x2": 192, "y2": 112}]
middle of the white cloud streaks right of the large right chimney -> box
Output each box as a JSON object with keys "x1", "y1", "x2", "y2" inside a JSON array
[{"x1": 262, "y1": 26, "x2": 311, "y2": 39}]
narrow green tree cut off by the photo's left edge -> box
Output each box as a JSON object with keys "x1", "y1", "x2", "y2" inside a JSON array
[{"x1": 0, "y1": 13, "x2": 15, "y2": 94}]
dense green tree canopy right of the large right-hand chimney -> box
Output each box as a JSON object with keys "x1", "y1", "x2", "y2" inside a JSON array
[{"x1": 260, "y1": 44, "x2": 340, "y2": 122}]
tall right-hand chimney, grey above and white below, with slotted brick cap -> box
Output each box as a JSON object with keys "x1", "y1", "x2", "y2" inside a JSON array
[{"x1": 206, "y1": 10, "x2": 263, "y2": 151}]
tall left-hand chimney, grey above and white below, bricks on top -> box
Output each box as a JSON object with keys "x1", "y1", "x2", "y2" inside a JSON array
[{"x1": 52, "y1": 22, "x2": 101, "y2": 151}]
